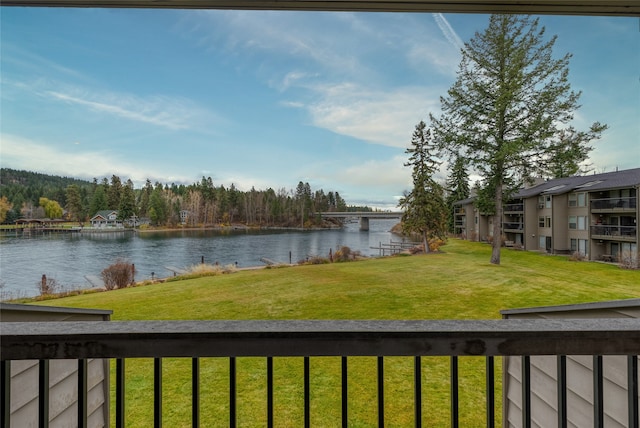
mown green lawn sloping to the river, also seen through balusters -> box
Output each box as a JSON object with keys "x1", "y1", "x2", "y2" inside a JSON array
[{"x1": 33, "y1": 240, "x2": 640, "y2": 427}]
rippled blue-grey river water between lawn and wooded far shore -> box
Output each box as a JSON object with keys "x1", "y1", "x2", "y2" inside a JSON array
[{"x1": 0, "y1": 220, "x2": 399, "y2": 298}]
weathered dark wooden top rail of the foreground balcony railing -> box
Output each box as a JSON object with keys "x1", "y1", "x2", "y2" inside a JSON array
[{"x1": 0, "y1": 319, "x2": 640, "y2": 360}]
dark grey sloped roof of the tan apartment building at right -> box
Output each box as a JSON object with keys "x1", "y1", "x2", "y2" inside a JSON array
[{"x1": 512, "y1": 168, "x2": 640, "y2": 198}]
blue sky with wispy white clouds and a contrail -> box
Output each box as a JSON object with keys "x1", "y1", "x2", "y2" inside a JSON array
[{"x1": 0, "y1": 7, "x2": 640, "y2": 208}]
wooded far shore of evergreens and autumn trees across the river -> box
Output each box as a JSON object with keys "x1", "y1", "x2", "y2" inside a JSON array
[{"x1": 0, "y1": 168, "x2": 372, "y2": 227}]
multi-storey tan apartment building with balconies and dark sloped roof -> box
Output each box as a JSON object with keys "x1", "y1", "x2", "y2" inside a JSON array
[{"x1": 454, "y1": 168, "x2": 640, "y2": 264}]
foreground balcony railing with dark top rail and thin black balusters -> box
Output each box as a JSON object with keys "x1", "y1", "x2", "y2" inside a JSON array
[{"x1": 0, "y1": 319, "x2": 640, "y2": 427}]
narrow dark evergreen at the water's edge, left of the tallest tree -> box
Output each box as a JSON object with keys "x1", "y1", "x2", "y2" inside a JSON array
[{"x1": 399, "y1": 121, "x2": 447, "y2": 252}]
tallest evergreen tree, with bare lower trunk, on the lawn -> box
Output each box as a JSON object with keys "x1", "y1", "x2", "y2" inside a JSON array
[{"x1": 431, "y1": 15, "x2": 606, "y2": 264}]
